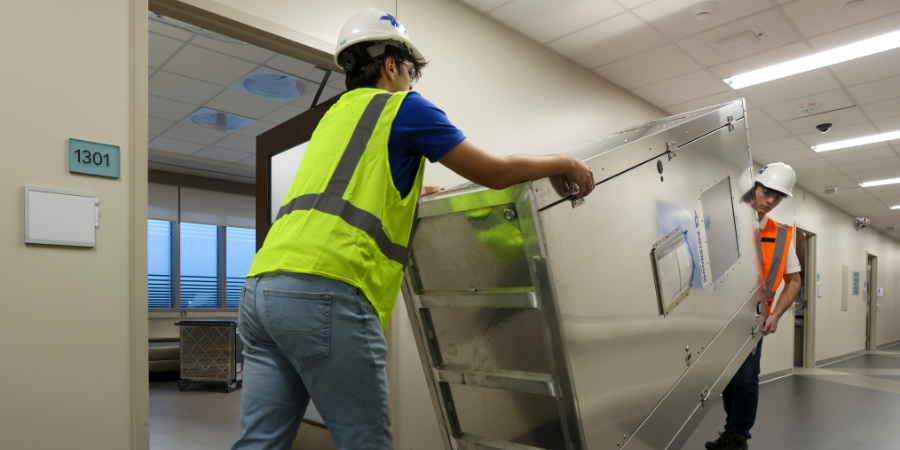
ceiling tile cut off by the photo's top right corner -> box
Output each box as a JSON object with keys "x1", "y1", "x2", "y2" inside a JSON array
[{"x1": 782, "y1": 0, "x2": 900, "y2": 37}]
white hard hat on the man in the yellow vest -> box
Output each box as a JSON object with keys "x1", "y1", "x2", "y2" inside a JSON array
[{"x1": 334, "y1": 8, "x2": 425, "y2": 70}]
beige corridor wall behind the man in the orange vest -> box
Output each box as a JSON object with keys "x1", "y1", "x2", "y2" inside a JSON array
[{"x1": 762, "y1": 183, "x2": 900, "y2": 375}]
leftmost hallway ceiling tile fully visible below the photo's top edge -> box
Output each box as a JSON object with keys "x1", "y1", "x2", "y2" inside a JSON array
[{"x1": 547, "y1": 13, "x2": 667, "y2": 68}]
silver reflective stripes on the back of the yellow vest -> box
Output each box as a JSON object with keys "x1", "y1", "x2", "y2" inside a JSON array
[{"x1": 275, "y1": 94, "x2": 409, "y2": 266}]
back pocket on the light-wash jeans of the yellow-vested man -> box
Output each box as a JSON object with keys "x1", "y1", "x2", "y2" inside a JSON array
[{"x1": 263, "y1": 290, "x2": 331, "y2": 333}]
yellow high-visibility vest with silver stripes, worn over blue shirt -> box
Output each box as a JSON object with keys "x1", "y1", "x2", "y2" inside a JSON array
[{"x1": 248, "y1": 88, "x2": 425, "y2": 329}]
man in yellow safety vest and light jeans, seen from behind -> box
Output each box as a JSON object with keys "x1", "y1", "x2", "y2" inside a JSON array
[{"x1": 232, "y1": 8, "x2": 595, "y2": 450}]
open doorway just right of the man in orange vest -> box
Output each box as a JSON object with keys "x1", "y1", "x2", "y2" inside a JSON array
[{"x1": 794, "y1": 228, "x2": 819, "y2": 367}]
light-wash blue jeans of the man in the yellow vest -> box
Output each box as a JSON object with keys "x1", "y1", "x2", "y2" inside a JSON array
[{"x1": 231, "y1": 273, "x2": 393, "y2": 450}]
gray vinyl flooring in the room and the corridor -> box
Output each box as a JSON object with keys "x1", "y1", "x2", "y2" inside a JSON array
[{"x1": 150, "y1": 348, "x2": 900, "y2": 450}]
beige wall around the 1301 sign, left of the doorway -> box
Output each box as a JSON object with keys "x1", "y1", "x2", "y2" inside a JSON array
[{"x1": 0, "y1": 0, "x2": 146, "y2": 450}]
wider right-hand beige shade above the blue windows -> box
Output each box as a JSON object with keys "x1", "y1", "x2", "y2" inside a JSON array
[{"x1": 181, "y1": 187, "x2": 256, "y2": 228}]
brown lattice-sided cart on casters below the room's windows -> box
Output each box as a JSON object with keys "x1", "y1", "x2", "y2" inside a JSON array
[{"x1": 176, "y1": 320, "x2": 244, "y2": 392}]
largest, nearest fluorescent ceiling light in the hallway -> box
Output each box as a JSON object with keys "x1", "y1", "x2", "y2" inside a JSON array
[{"x1": 724, "y1": 31, "x2": 900, "y2": 89}]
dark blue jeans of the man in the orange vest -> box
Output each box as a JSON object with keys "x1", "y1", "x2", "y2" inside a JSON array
[{"x1": 722, "y1": 339, "x2": 762, "y2": 439}]
